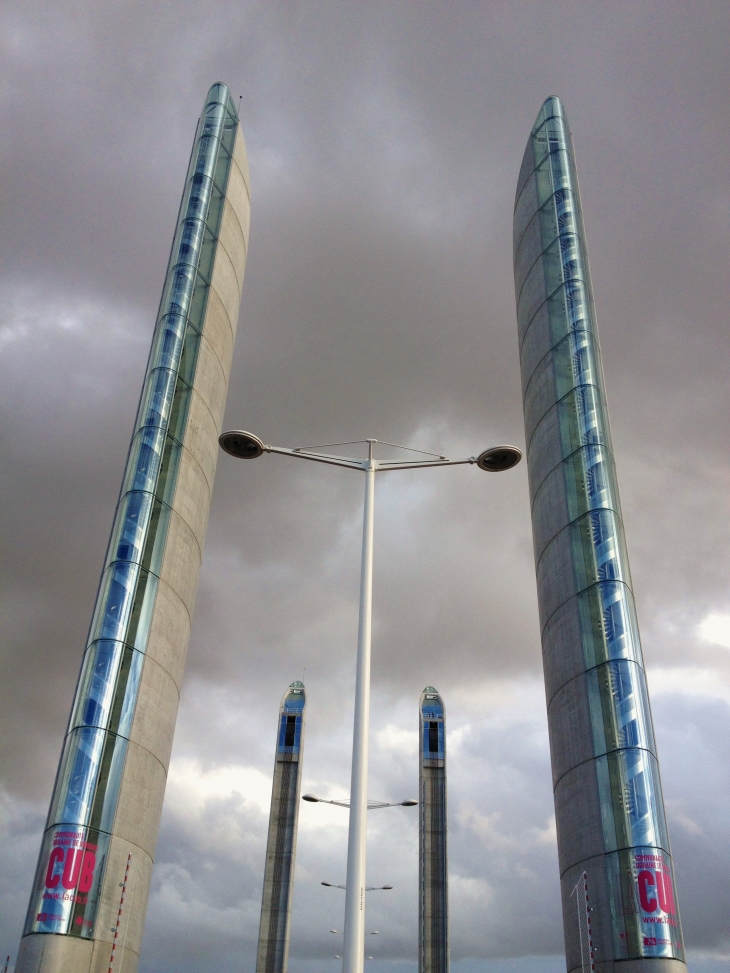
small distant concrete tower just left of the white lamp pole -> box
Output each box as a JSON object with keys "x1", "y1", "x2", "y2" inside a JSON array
[{"x1": 256, "y1": 682, "x2": 306, "y2": 973}]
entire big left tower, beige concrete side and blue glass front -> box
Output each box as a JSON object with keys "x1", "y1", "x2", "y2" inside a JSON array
[{"x1": 16, "y1": 84, "x2": 250, "y2": 973}]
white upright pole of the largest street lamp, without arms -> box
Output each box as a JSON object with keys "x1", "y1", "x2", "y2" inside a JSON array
[{"x1": 342, "y1": 439, "x2": 375, "y2": 973}]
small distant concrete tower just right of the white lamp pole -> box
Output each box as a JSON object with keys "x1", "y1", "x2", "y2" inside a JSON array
[{"x1": 418, "y1": 686, "x2": 449, "y2": 973}]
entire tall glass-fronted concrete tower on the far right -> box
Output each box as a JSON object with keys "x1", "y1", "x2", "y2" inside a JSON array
[{"x1": 514, "y1": 98, "x2": 684, "y2": 973}]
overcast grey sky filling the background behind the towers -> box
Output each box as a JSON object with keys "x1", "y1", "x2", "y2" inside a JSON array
[{"x1": 0, "y1": 0, "x2": 730, "y2": 973}]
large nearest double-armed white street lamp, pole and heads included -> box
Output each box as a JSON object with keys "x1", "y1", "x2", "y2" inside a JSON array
[{"x1": 218, "y1": 429, "x2": 522, "y2": 973}]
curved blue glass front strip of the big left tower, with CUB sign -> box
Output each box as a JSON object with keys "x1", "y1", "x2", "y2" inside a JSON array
[{"x1": 24, "y1": 85, "x2": 238, "y2": 938}]
